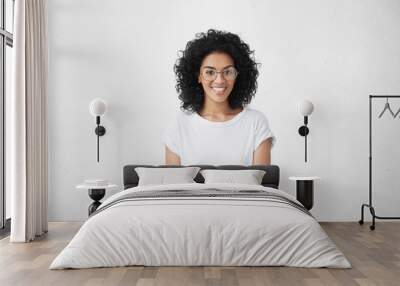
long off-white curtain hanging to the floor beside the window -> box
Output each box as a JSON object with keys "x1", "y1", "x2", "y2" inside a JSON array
[{"x1": 6, "y1": 0, "x2": 48, "y2": 242}]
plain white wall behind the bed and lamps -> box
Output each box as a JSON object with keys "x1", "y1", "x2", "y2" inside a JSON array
[{"x1": 48, "y1": 0, "x2": 400, "y2": 221}]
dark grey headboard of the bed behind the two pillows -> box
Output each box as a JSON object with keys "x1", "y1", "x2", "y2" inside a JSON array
[{"x1": 124, "y1": 165, "x2": 279, "y2": 189}]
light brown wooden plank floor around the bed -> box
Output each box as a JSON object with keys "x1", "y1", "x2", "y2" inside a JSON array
[{"x1": 0, "y1": 222, "x2": 400, "y2": 286}]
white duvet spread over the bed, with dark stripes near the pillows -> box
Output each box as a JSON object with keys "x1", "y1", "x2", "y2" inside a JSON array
[{"x1": 50, "y1": 184, "x2": 351, "y2": 269}]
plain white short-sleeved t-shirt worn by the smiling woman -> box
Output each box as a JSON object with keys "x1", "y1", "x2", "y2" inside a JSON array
[{"x1": 163, "y1": 107, "x2": 276, "y2": 165}]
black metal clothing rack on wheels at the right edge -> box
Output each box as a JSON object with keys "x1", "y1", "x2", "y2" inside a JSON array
[{"x1": 358, "y1": 95, "x2": 400, "y2": 230}]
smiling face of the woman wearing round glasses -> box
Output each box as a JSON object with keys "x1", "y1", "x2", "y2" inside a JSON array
[{"x1": 199, "y1": 52, "x2": 236, "y2": 103}]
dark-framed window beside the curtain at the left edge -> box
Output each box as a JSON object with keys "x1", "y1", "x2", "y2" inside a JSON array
[{"x1": 0, "y1": 0, "x2": 14, "y2": 233}]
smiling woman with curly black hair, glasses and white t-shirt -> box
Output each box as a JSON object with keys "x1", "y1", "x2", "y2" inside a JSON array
[{"x1": 163, "y1": 30, "x2": 275, "y2": 165}]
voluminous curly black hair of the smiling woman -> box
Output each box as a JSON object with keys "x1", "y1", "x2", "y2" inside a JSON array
[{"x1": 174, "y1": 29, "x2": 258, "y2": 112}]
